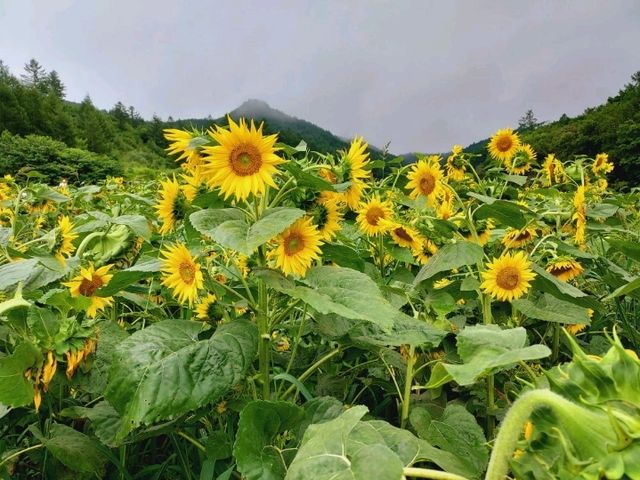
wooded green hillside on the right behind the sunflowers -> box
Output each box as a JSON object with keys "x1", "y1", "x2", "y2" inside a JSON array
[{"x1": 466, "y1": 72, "x2": 640, "y2": 189}]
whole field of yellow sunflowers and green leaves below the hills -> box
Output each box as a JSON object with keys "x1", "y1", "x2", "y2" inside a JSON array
[{"x1": 0, "y1": 118, "x2": 640, "y2": 480}]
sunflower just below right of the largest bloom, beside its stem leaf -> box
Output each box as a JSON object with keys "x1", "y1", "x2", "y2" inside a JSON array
[{"x1": 270, "y1": 217, "x2": 322, "y2": 277}]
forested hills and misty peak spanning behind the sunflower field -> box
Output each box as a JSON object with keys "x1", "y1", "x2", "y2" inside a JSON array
[{"x1": 0, "y1": 59, "x2": 640, "y2": 188}]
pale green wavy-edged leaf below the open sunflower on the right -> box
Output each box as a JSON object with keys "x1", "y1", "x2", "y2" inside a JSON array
[{"x1": 442, "y1": 325, "x2": 551, "y2": 385}]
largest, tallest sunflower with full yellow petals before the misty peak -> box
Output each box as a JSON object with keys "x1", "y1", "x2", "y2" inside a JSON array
[{"x1": 203, "y1": 117, "x2": 284, "y2": 200}]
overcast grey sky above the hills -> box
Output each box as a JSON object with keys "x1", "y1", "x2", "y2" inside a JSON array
[{"x1": 0, "y1": 0, "x2": 640, "y2": 153}]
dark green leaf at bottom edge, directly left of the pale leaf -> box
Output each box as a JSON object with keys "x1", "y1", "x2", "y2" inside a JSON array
[{"x1": 233, "y1": 400, "x2": 304, "y2": 480}]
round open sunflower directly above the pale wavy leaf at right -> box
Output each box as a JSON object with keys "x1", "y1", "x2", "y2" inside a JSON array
[{"x1": 480, "y1": 252, "x2": 536, "y2": 302}]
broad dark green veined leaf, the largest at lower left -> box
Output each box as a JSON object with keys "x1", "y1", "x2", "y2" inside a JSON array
[{"x1": 105, "y1": 320, "x2": 258, "y2": 441}]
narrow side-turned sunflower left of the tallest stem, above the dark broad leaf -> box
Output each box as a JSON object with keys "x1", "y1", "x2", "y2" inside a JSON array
[{"x1": 160, "y1": 243, "x2": 203, "y2": 306}]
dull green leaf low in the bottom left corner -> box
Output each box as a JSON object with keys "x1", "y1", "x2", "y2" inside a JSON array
[{"x1": 31, "y1": 423, "x2": 106, "y2": 478}]
